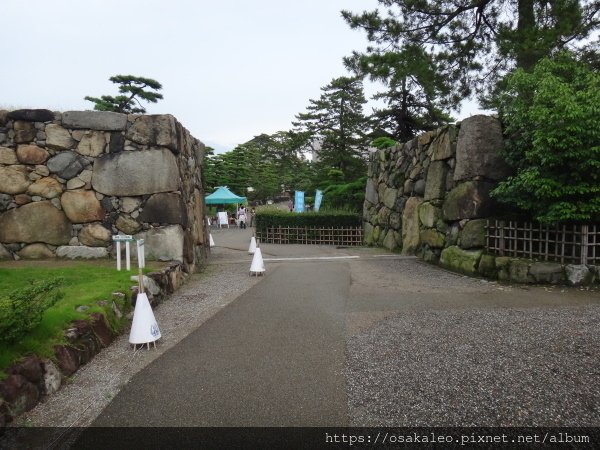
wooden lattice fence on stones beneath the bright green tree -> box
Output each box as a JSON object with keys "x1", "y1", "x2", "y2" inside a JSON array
[{"x1": 486, "y1": 220, "x2": 600, "y2": 265}]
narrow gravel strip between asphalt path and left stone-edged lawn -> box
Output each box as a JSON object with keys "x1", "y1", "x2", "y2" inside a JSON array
[{"x1": 16, "y1": 248, "x2": 260, "y2": 427}]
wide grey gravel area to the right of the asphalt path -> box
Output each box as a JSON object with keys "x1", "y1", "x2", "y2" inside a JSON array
[{"x1": 346, "y1": 261, "x2": 600, "y2": 427}]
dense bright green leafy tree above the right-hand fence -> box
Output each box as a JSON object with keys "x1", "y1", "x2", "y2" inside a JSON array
[{"x1": 494, "y1": 53, "x2": 600, "y2": 223}]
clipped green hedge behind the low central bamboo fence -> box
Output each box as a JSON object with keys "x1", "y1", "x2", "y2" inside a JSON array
[{"x1": 256, "y1": 208, "x2": 361, "y2": 232}]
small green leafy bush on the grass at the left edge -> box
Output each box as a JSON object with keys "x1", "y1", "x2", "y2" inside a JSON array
[{"x1": 0, "y1": 278, "x2": 64, "y2": 343}]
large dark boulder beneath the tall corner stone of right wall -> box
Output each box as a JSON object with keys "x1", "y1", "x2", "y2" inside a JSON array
[{"x1": 442, "y1": 181, "x2": 493, "y2": 221}]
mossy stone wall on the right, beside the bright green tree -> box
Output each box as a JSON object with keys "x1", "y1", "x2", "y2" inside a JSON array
[{"x1": 363, "y1": 115, "x2": 508, "y2": 262}]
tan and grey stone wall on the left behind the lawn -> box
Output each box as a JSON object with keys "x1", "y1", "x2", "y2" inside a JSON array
[{"x1": 0, "y1": 110, "x2": 208, "y2": 272}]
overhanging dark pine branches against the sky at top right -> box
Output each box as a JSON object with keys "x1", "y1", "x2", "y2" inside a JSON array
[{"x1": 342, "y1": 0, "x2": 600, "y2": 98}]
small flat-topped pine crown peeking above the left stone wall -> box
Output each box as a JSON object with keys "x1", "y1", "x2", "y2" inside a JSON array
[{"x1": 85, "y1": 75, "x2": 163, "y2": 114}]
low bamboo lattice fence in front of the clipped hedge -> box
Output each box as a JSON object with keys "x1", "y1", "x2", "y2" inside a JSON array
[{"x1": 256, "y1": 227, "x2": 363, "y2": 246}]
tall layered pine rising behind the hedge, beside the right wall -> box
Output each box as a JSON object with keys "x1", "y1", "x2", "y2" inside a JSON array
[{"x1": 294, "y1": 77, "x2": 369, "y2": 181}]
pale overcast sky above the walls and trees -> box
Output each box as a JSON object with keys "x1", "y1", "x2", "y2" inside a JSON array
[{"x1": 0, "y1": 0, "x2": 488, "y2": 151}]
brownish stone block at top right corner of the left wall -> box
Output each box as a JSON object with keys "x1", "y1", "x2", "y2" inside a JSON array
[{"x1": 126, "y1": 115, "x2": 179, "y2": 151}]
